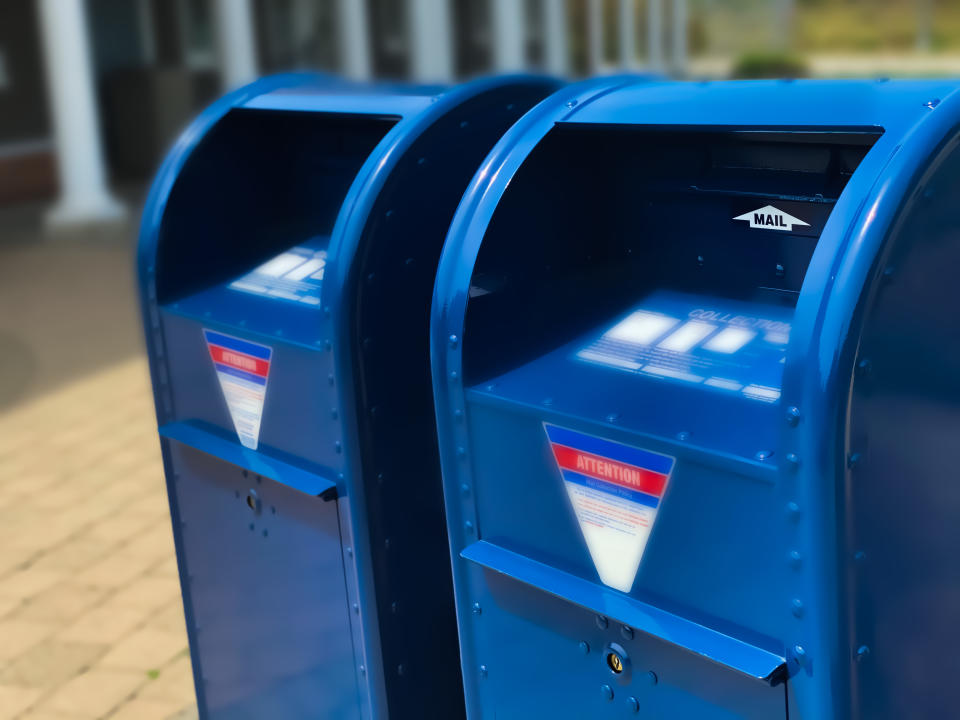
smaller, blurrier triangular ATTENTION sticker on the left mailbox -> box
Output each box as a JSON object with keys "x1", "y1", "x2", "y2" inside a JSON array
[{"x1": 203, "y1": 329, "x2": 273, "y2": 450}]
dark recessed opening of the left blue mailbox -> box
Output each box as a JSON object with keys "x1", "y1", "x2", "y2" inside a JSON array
[{"x1": 157, "y1": 109, "x2": 398, "y2": 304}]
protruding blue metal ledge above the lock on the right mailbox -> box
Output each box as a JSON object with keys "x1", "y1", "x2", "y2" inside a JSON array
[{"x1": 460, "y1": 540, "x2": 786, "y2": 685}]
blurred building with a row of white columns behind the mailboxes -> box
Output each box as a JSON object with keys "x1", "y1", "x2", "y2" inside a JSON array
[{"x1": 0, "y1": 0, "x2": 686, "y2": 223}]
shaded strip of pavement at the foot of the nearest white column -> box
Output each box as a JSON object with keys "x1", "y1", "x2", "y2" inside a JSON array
[{"x1": 0, "y1": 193, "x2": 143, "y2": 412}]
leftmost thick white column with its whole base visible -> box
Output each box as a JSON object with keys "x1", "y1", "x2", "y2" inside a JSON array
[{"x1": 40, "y1": 0, "x2": 125, "y2": 225}]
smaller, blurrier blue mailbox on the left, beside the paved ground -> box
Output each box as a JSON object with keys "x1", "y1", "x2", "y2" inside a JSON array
[{"x1": 139, "y1": 75, "x2": 556, "y2": 720}]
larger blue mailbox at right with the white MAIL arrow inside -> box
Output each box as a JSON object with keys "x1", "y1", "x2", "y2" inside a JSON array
[{"x1": 432, "y1": 80, "x2": 960, "y2": 720}]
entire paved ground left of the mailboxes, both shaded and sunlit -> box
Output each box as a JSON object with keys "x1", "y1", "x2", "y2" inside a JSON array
[{"x1": 0, "y1": 204, "x2": 196, "y2": 720}]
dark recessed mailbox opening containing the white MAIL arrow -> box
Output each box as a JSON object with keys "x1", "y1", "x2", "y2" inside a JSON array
[{"x1": 464, "y1": 124, "x2": 880, "y2": 384}]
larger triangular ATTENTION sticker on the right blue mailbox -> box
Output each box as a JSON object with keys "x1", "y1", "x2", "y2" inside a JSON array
[{"x1": 543, "y1": 423, "x2": 675, "y2": 592}]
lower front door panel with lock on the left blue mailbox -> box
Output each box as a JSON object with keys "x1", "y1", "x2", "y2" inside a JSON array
[{"x1": 168, "y1": 441, "x2": 359, "y2": 720}]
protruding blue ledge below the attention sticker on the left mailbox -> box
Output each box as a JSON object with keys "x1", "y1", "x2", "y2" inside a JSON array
[{"x1": 160, "y1": 422, "x2": 337, "y2": 500}]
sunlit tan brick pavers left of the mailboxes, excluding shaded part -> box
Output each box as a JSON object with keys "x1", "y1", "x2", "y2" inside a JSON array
[{"x1": 0, "y1": 358, "x2": 196, "y2": 720}]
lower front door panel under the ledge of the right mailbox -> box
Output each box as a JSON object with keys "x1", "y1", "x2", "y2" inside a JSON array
[{"x1": 470, "y1": 565, "x2": 788, "y2": 720}]
